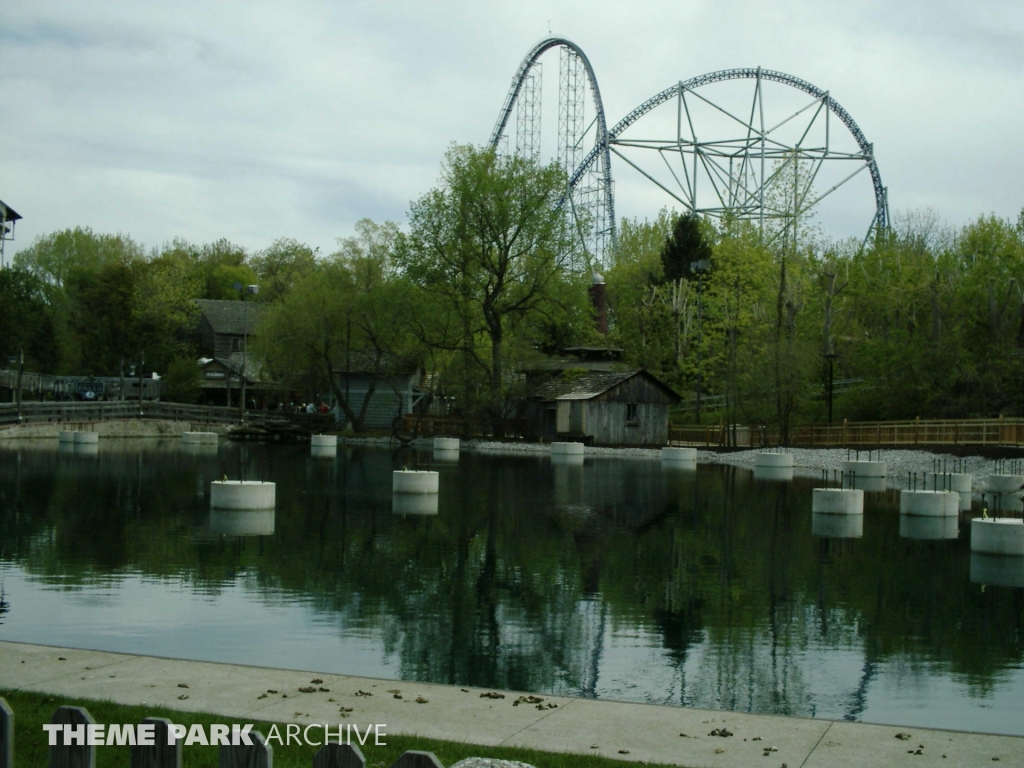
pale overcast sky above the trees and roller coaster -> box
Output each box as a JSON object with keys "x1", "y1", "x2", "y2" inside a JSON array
[{"x1": 0, "y1": 0, "x2": 1024, "y2": 262}]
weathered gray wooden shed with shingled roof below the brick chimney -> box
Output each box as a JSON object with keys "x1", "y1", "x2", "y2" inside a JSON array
[{"x1": 525, "y1": 370, "x2": 680, "y2": 445}]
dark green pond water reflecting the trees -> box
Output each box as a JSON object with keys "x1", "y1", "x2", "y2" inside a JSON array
[{"x1": 0, "y1": 440, "x2": 1024, "y2": 735}]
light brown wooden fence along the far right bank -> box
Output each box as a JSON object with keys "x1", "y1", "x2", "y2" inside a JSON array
[{"x1": 669, "y1": 419, "x2": 1024, "y2": 447}]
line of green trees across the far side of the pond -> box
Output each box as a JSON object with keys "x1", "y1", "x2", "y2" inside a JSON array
[{"x1": 0, "y1": 146, "x2": 1024, "y2": 437}]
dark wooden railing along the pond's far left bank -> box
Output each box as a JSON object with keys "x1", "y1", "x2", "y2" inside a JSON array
[{"x1": 0, "y1": 400, "x2": 334, "y2": 436}]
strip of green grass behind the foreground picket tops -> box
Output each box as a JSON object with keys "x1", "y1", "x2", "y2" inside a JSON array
[{"x1": 0, "y1": 690, "x2": 688, "y2": 768}]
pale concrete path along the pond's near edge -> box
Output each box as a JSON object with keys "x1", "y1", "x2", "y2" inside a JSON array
[{"x1": 0, "y1": 642, "x2": 1024, "y2": 768}]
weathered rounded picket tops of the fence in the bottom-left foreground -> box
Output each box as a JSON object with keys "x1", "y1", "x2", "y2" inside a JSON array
[{"x1": 0, "y1": 698, "x2": 444, "y2": 768}]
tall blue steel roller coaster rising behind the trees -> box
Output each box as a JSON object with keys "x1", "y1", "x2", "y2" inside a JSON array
[{"x1": 489, "y1": 37, "x2": 889, "y2": 268}]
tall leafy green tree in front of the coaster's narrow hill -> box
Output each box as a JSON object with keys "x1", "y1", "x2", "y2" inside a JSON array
[{"x1": 399, "y1": 146, "x2": 589, "y2": 434}]
